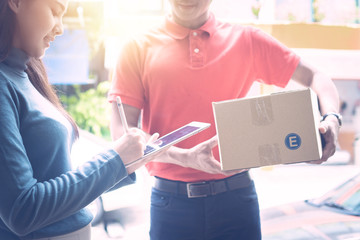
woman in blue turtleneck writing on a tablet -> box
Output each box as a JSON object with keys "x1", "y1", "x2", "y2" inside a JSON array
[{"x1": 0, "y1": 0, "x2": 157, "y2": 240}]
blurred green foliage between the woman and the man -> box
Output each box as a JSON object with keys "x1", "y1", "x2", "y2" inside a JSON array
[{"x1": 59, "y1": 81, "x2": 111, "y2": 140}]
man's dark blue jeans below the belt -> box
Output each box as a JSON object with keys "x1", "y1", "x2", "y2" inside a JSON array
[{"x1": 150, "y1": 182, "x2": 261, "y2": 240}]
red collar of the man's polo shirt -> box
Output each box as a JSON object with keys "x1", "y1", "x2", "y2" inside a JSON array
[{"x1": 165, "y1": 13, "x2": 216, "y2": 39}]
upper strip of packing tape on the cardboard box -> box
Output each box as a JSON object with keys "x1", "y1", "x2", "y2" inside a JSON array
[{"x1": 250, "y1": 97, "x2": 274, "y2": 126}]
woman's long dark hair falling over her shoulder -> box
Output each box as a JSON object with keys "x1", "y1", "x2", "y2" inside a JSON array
[{"x1": 0, "y1": 0, "x2": 79, "y2": 137}]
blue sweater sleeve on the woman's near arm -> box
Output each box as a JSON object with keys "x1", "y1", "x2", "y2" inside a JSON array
[{"x1": 0, "y1": 79, "x2": 129, "y2": 236}]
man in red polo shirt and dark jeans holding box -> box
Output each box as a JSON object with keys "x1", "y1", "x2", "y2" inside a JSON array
[{"x1": 109, "y1": 0, "x2": 340, "y2": 240}]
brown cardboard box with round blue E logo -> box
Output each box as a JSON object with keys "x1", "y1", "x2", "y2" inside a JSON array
[{"x1": 213, "y1": 89, "x2": 322, "y2": 170}]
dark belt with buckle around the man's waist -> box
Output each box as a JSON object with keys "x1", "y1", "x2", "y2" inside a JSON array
[{"x1": 154, "y1": 172, "x2": 252, "y2": 198}]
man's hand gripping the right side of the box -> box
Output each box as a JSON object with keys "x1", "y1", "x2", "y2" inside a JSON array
[{"x1": 309, "y1": 116, "x2": 339, "y2": 164}]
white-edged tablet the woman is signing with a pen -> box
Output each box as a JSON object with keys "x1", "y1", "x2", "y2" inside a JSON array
[{"x1": 125, "y1": 122, "x2": 211, "y2": 167}]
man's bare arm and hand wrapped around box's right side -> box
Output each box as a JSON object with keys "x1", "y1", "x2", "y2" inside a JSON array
[{"x1": 292, "y1": 61, "x2": 340, "y2": 163}]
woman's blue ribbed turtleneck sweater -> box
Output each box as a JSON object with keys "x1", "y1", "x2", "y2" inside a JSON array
[{"x1": 0, "y1": 49, "x2": 132, "y2": 240}]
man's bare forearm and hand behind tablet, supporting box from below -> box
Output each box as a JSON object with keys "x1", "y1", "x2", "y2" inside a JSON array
[{"x1": 110, "y1": 102, "x2": 242, "y2": 175}]
